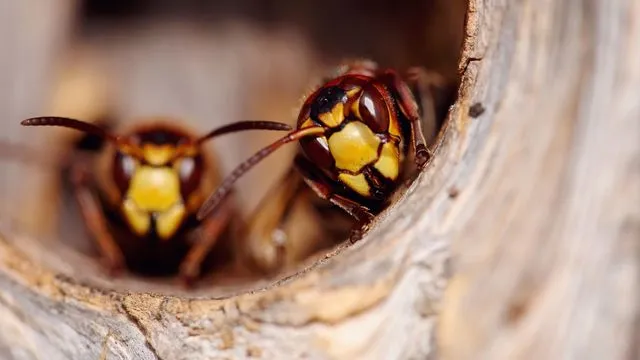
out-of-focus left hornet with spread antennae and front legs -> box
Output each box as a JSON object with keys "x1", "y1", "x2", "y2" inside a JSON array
[{"x1": 22, "y1": 117, "x2": 290, "y2": 283}]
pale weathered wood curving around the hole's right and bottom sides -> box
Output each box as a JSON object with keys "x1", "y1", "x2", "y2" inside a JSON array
[{"x1": 0, "y1": 0, "x2": 640, "y2": 359}]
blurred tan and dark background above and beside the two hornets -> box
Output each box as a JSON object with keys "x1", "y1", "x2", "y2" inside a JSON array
[{"x1": 0, "y1": 0, "x2": 466, "y2": 292}]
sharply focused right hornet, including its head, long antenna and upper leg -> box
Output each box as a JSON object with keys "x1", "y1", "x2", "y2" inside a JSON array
[{"x1": 198, "y1": 62, "x2": 440, "y2": 248}]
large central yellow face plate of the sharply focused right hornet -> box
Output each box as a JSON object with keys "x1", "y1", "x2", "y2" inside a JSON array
[{"x1": 329, "y1": 121, "x2": 380, "y2": 172}]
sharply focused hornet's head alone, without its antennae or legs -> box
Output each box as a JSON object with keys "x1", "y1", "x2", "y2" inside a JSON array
[{"x1": 297, "y1": 69, "x2": 417, "y2": 211}]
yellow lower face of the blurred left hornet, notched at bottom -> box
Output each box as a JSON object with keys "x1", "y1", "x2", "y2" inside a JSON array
[{"x1": 122, "y1": 166, "x2": 186, "y2": 239}]
